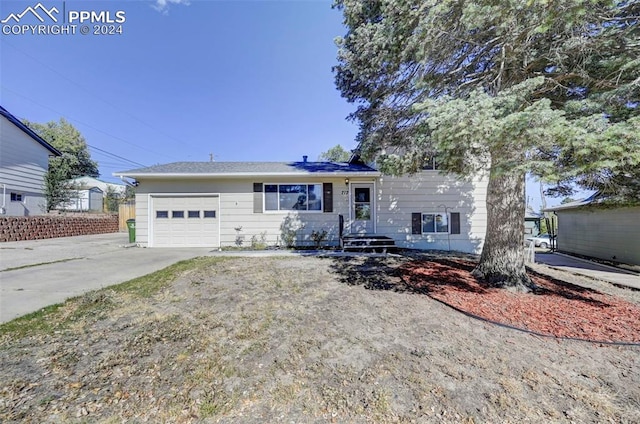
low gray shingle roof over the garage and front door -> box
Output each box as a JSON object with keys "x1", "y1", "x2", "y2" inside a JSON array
[{"x1": 115, "y1": 162, "x2": 378, "y2": 176}]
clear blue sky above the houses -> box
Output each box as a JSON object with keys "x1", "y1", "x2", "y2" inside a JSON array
[{"x1": 0, "y1": 0, "x2": 576, "y2": 210}]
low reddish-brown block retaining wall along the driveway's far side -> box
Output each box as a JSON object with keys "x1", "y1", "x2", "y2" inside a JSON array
[{"x1": 0, "y1": 215, "x2": 118, "y2": 242}]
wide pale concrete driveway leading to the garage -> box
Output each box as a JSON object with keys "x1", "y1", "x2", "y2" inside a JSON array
[{"x1": 0, "y1": 233, "x2": 212, "y2": 323}]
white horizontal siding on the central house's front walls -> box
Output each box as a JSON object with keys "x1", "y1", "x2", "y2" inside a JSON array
[{"x1": 136, "y1": 171, "x2": 487, "y2": 252}]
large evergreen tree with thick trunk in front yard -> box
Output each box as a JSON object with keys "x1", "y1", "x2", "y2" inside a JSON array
[{"x1": 335, "y1": 0, "x2": 640, "y2": 290}]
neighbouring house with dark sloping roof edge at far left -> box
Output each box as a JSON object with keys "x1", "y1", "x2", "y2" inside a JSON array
[{"x1": 0, "y1": 106, "x2": 62, "y2": 216}]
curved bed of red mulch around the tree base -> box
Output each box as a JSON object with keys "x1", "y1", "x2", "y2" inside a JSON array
[{"x1": 400, "y1": 260, "x2": 640, "y2": 343}]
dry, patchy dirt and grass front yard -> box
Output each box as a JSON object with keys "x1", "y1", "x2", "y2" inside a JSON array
[{"x1": 0, "y1": 253, "x2": 640, "y2": 423}]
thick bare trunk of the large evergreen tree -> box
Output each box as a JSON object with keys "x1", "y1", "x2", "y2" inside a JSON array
[{"x1": 473, "y1": 167, "x2": 536, "y2": 292}]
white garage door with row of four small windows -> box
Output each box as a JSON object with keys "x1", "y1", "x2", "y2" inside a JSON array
[{"x1": 151, "y1": 195, "x2": 220, "y2": 247}]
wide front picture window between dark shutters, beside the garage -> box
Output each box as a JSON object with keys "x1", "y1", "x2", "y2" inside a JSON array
[{"x1": 264, "y1": 184, "x2": 322, "y2": 212}]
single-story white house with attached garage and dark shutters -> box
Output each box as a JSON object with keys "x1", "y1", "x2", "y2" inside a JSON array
[{"x1": 114, "y1": 157, "x2": 487, "y2": 253}]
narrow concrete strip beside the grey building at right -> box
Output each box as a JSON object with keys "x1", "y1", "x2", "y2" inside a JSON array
[{"x1": 536, "y1": 253, "x2": 640, "y2": 290}]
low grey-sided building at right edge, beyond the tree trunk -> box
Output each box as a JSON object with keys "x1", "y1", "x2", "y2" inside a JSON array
[{"x1": 547, "y1": 193, "x2": 640, "y2": 265}]
